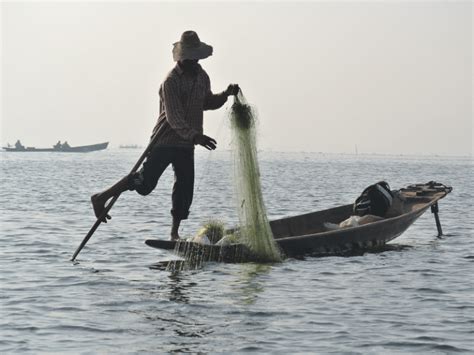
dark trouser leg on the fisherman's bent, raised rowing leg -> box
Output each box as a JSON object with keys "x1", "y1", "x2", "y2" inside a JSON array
[{"x1": 129, "y1": 147, "x2": 175, "y2": 195}]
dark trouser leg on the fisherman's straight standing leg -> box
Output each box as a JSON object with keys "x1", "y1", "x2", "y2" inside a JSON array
[{"x1": 171, "y1": 148, "x2": 194, "y2": 220}]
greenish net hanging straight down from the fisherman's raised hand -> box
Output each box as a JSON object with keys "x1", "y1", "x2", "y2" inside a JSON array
[{"x1": 229, "y1": 91, "x2": 281, "y2": 261}]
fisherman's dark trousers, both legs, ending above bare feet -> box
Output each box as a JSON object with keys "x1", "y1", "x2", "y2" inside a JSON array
[{"x1": 129, "y1": 146, "x2": 194, "y2": 220}]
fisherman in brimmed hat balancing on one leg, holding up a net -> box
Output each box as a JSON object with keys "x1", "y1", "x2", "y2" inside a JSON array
[{"x1": 91, "y1": 31, "x2": 240, "y2": 240}]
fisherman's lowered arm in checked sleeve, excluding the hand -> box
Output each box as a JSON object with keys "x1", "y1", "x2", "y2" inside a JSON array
[{"x1": 163, "y1": 79, "x2": 199, "y2": 142}]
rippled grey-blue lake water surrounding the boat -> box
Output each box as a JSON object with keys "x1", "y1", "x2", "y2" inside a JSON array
[{"x1": 0, "y1": 150, "x2": 474, "y2": 354}]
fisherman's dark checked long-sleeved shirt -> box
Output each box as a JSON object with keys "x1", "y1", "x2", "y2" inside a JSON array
[{"x1": 154, "y1": 64, "x2": 227, "y2": 147}]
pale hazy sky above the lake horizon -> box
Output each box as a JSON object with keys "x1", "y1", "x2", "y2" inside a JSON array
[{"x1": 0, "y1": 1, "x2": 474, "y2": 155}]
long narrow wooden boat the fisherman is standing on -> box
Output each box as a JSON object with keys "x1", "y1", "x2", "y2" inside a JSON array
[{"x1": 145, "y1": 181, "x2": 452, "y2": 262}]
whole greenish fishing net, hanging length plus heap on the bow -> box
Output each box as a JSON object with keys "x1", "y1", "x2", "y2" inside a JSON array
[{"x1": 166, "y1": 91, "x2": 282, "y2": 271}]
